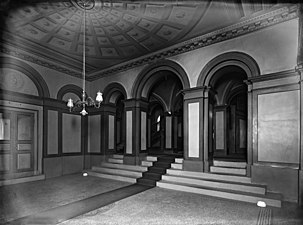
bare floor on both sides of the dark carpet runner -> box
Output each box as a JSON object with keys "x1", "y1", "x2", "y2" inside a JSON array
[{"x1": 0, "y1": 174, "x2": 303, "y2": 225}]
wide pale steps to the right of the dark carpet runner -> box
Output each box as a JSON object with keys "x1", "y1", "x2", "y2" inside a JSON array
[{"x1": 157, "y1": 161, "x2": 281, "y2": 207}]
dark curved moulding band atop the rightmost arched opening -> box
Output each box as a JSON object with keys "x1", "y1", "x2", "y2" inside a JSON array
[{"x1": 197, "y1": 52, "x2": 260, "y2": 86}]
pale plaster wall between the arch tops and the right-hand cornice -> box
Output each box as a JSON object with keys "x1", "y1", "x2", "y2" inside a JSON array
[{"x1": 91, "y1": 19, "x2": 298, "y2": 92}]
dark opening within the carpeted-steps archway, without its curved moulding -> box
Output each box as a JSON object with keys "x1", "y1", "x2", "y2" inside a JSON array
[{"x1": 147, "y1": 71, "x2": 183, "y2": 154}]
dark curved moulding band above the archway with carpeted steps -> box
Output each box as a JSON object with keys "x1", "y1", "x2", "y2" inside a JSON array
[{"x1": 131, "y1": 60, "x2": 190, "y2": 99}]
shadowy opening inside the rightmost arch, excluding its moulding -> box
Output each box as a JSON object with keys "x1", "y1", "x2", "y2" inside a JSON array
[{"x1": 209, "y1": 66, "x2": 247, "y2": 161}]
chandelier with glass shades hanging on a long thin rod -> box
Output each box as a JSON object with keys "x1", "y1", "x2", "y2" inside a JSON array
[{"x1": 67, "y1": 1, "x2": 103, "y2": 116}]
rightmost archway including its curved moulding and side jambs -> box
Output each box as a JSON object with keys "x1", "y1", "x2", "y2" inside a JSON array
[{"x1": 197, "y1": 52, "x2": 260, "y2": 173}]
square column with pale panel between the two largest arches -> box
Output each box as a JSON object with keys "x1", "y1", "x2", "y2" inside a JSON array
[{"x1": 183, "y1": 88, "x2": 205, "y2": 172}]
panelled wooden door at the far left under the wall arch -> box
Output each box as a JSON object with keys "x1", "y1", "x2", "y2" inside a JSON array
[{"x1": 0, "y1": 110, "x2": 35, "y2": 178}]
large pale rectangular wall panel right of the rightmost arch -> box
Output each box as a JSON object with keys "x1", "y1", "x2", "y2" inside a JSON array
[{"x1": 258, "y1": 90, "x2": 300, "y2": 163}]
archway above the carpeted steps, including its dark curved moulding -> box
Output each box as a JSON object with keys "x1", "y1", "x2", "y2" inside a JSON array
[{"x1": 132, "y1": 60, "x2": 189, "y2": 155}]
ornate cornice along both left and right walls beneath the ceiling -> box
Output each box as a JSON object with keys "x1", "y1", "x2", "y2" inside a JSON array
[{"x1": 0, "y1": 5, "x2": 298, "y2": 81}]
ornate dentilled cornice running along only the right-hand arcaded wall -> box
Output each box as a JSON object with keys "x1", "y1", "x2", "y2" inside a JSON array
[{"x1": 88, "y1": 5, "x2": 298, "y2": 81}]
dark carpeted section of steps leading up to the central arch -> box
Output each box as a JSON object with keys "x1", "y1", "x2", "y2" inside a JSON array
[{"x1": 137, "y1": 156, "x2": 175, "y2": 187}]
